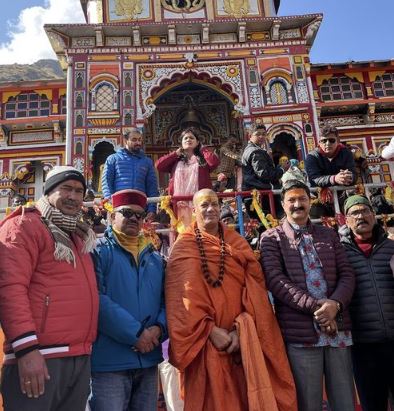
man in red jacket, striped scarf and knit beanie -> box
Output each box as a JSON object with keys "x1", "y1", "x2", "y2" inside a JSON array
[{"x1": 0, "y1": 166, "x2": 98, "y2": 411}]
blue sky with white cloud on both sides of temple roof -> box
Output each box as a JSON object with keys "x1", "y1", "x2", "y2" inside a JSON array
[{"x1": 0, "y1": 0, "x2": 394, "y2": 64}]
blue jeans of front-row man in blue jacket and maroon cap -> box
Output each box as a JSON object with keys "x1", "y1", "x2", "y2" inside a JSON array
[{"x1": 90, "y1": 366, "x2": 158, "y2": 411}]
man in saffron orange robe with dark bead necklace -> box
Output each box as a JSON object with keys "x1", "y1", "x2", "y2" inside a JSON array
[{"x1": 166, "y1": 189, "x2": 297, "y2": 411}]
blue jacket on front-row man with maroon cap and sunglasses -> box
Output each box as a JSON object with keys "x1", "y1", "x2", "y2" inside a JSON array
[{"x1": 92, "y1": 228, "x2": 167, "y2": 372}]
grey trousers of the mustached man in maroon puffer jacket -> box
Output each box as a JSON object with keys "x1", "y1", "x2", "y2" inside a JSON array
[{"x1": 287, "y1": 344, "x2": 354, "y2": 411}]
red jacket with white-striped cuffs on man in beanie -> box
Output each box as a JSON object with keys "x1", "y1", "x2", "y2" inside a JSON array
[{"x1": 0, "y1": 208, "x2": 98, "y2": 363}]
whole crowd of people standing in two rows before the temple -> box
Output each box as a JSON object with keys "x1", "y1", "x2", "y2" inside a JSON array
[{"x1": 0, "y1": 126, "x2": 394, "y2": 411}]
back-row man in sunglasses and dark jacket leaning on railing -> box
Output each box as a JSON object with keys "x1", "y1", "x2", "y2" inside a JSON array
[{"x1": 305, "y1": 126, "x2": 356, "y2": 187}]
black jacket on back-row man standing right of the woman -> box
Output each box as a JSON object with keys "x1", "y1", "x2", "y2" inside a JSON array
[{"x1": 242, "y1": 141, "x2": 283, "y2": 190}]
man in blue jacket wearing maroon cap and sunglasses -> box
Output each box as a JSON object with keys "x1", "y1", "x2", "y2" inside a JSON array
[{"x1": 91, "y1": 189, "x2": 167, "y2": 411}]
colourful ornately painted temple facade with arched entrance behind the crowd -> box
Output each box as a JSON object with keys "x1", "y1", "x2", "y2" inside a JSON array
[{"x1": 0, "y1": 0, "x2": 394, "y2": 204}]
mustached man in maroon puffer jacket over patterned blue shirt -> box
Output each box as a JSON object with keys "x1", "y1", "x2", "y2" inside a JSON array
[{"x1": 260, "y1": 180, "x2": 355, "y2": 411}]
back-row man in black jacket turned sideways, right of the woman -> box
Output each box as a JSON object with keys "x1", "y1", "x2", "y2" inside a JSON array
[{"x1": 241, "y1": 125, "x2": 286, "y2": 218}]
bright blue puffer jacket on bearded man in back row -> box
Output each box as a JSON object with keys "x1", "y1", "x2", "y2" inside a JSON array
[{"x1": 101, "y1": 148, "x2": 159, "y2": 212}]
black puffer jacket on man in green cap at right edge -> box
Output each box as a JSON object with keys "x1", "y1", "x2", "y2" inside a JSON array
[{"x1": 340, "y1": 225, "x2": 394, "y2": 343}]
